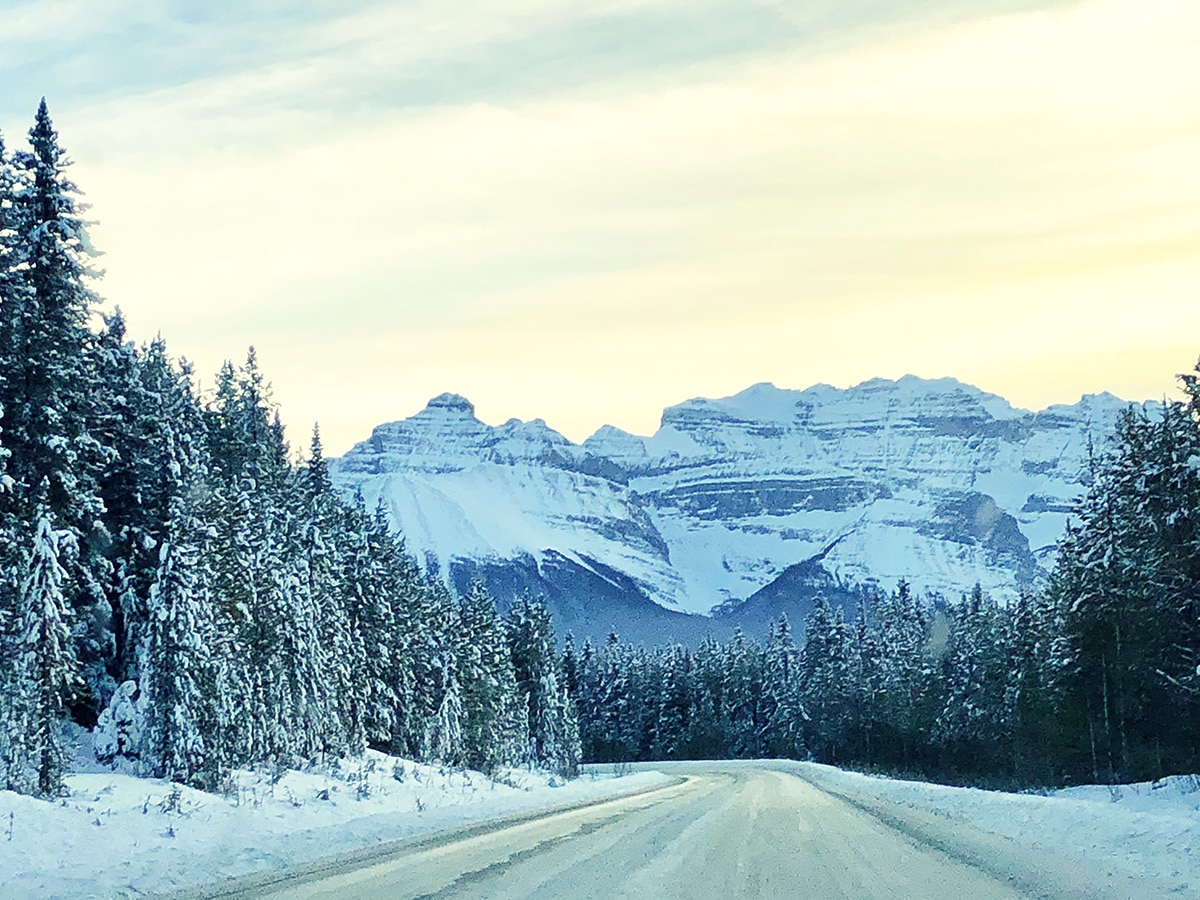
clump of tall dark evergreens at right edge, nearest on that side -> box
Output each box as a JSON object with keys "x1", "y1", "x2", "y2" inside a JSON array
[{"x1": 1051, "y1": 376, "x2": 1200, "y2": 779}]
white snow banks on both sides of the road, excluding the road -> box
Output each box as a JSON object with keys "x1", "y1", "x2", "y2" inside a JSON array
[{"x1": 0, "y1": 751, "x2": 1200, "y2": 898}]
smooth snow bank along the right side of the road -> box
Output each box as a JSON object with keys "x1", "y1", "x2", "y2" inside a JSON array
[{"x1": 802, "y1": 763, "x2": 1200, "y2": 896}]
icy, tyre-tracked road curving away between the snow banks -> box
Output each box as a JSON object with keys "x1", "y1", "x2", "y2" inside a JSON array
[{"x1": 234, "y1": 764, "x2": 1054, "y2": 900}]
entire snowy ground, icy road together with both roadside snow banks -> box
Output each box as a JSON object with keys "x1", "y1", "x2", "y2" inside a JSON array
[{"x1": 7, "y1": 752, "x2": 1200, "y2": 900}]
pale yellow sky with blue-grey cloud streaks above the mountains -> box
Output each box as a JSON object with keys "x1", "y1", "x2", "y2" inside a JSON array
[{"x1": 0, "y1": 0, "x2": 1200, "y2": 455}]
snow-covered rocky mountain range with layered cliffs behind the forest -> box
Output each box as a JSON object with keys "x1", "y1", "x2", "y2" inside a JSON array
[{"x1": 332, "y1": 377, "x2": 1153, "y2": 643}]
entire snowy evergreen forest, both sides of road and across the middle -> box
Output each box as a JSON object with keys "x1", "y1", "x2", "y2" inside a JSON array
[{"x1": 0, "y1": 101, "x2": 1200, "y2": 797}]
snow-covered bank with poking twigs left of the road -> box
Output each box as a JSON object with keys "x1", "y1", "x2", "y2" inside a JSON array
[{"x1": 0, "y1": 751, "x2": 671, "y2": 898}]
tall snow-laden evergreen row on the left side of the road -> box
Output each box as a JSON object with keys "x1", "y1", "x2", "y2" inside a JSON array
[{"x1": 0, "y1": 100, "x2": 580, "y2": 796}]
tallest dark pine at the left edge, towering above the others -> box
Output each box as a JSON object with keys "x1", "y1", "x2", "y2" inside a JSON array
[{"x1": 0, "y1": 100, "x2": 112, "y2": 709}]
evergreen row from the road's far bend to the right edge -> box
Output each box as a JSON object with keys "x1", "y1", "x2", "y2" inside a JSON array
[{"x1": 564, "y1": 376, "x2": 1200, "y2": 786}]
